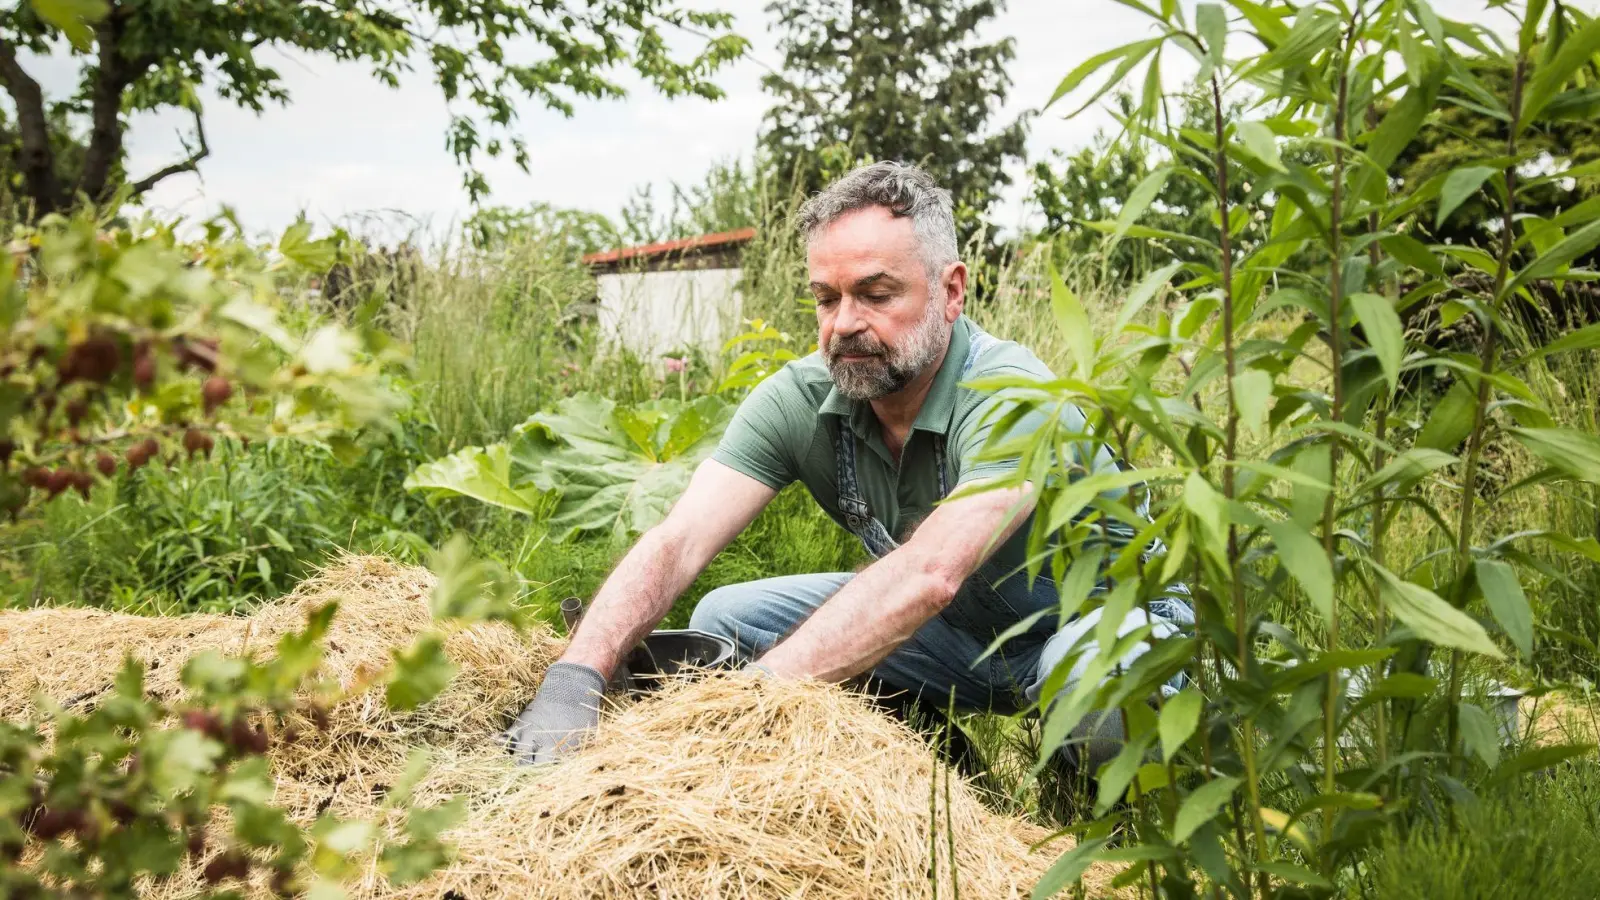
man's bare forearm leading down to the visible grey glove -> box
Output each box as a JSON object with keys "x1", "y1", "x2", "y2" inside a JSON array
[{"x1": 562, "y1": 460, "x2": 778, "y2": 677}]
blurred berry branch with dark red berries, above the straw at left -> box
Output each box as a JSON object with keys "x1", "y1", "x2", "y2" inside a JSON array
[{"x1": 0, "y1": 208, "x2": 400, "y2": 514}]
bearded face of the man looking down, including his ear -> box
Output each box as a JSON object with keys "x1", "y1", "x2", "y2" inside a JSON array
[{"x1": 806, "y1": 207, "x2": 966, "y2": 400}]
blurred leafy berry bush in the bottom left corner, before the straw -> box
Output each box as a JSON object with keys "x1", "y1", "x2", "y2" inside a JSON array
[{"x1": 0, "y1": 538, "x2": 526, "y2": 898}]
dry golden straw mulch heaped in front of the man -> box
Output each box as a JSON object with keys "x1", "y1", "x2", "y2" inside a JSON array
[{"x1": 0, "y1": 557, "x2": 1115, "y2": 900}]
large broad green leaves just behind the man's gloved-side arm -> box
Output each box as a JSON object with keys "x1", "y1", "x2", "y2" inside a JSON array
[{"x1": 405, "y1": 394, "x2": 733, "y2": 540}]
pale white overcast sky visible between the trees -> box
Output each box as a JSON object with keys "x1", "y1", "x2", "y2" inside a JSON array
[{"x1": 32, "y1": 0, "x2": 1482, "y2": 241}]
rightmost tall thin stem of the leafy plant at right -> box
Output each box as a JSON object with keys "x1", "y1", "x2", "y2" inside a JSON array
[{"x1": 1445, "y1": 53, "x2": 1528, "y2": 762}]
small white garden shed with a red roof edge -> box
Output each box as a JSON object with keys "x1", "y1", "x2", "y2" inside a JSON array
[{"x1": 584, "y1": 227, "x2": 755, "y2": 359}]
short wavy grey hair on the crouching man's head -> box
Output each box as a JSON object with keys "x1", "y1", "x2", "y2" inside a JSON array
[{"x1": 797, "y1": 162, "x2": 960, "y2": 280}]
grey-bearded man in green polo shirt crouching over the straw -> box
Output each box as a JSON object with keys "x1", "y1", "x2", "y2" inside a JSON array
[{"x1": 509, "y1": 162, "x2": 1189, "y2": 762}]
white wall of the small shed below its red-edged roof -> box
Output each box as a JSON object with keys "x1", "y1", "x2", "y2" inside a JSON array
[{"x1": 595, "y1": 269, "x2": 744, "y2": 359}]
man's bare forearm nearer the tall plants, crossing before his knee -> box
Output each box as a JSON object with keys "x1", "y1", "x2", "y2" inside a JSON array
[{"x1": 760, "y1": 487, "x2": 1034, "y2": 681}]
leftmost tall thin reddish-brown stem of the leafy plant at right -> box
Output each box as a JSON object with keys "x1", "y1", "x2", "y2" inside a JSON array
[{"x1": 1211, "y1": 74, "x2": 1267, "y2": 895}]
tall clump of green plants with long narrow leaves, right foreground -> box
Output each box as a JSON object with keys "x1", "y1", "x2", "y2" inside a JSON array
[{"x1": 982, "y1": 0, "x2": 1600, "y2": 897}]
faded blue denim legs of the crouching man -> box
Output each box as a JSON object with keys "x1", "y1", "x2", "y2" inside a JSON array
[{"x1": 690, "y1": 572, "x2": 1178, "y2": 713}]
